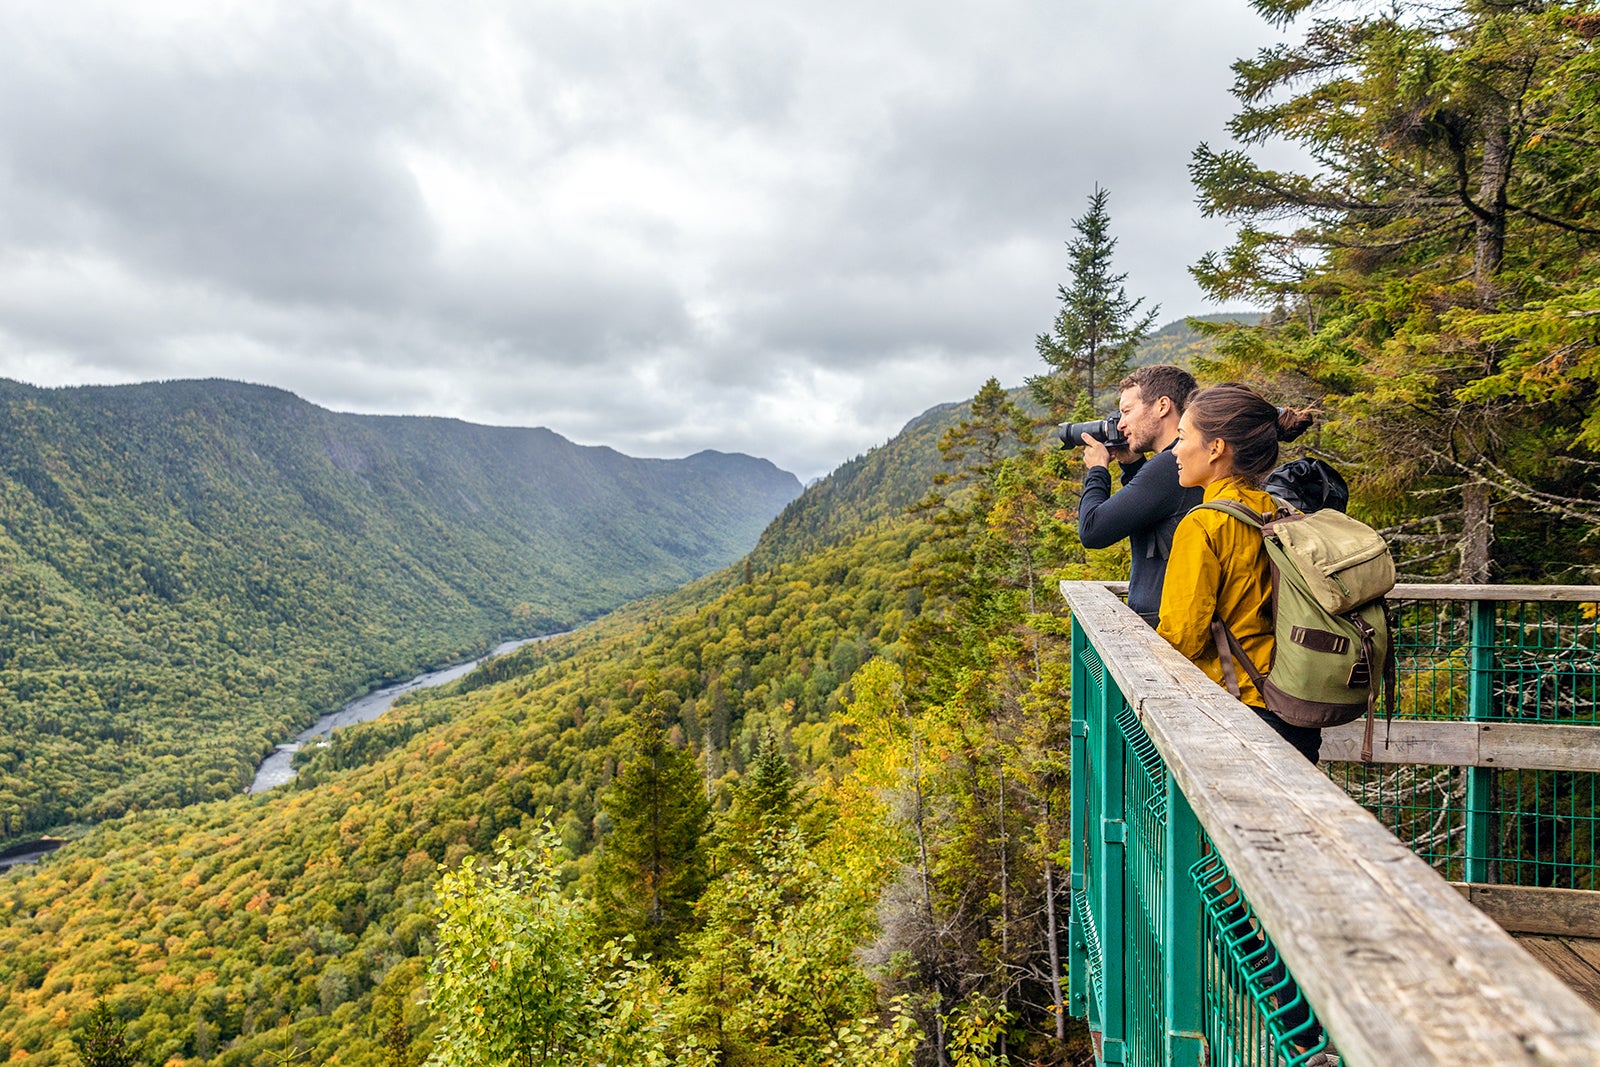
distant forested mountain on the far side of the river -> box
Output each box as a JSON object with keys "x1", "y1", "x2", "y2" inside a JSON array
[{"x1": 0, "y1": 381, "x2": 800, "y2": 840}]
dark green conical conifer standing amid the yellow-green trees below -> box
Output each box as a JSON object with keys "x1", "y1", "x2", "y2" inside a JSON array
[{"x1": 595, "y1": 678, "x2": 710, "y2": 958}]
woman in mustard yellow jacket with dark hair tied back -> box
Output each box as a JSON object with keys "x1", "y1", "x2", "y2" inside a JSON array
[{"x1": 1157, "y1": 382, "x2": 1322, "y2": 763}]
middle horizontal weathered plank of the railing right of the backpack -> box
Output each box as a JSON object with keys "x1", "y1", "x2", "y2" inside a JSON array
[{"x1": 1322, "y1": 720, "x2": 1600, "y2": 771}]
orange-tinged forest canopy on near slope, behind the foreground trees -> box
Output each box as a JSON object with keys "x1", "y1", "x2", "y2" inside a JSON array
[{"x1": 0, "y1": 502, "x2": 922, "y2": 1067}]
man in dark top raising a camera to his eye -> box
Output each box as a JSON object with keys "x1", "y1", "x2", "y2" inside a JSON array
[{"x1": 1078, "y1": 363, "x2": 1205, "y2": 625}]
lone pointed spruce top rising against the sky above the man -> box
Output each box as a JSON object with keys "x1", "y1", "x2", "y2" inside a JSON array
[{"x1": 1027, "y1": 186, "x2": 1160, "y2": 421}]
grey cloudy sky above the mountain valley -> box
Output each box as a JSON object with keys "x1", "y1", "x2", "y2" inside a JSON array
[{"x1": 0, "y1": 0, "x2": 1270, "y2": 478}]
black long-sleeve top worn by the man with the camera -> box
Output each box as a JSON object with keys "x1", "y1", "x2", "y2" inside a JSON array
[{"x1": 1078, "y1": 445, "x2": 1205, "y2": 625}]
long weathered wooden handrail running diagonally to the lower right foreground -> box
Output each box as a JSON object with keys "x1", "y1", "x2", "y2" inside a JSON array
[{"x1": 1062, "y1": 582, "x2": 1600, "y2": 1067}]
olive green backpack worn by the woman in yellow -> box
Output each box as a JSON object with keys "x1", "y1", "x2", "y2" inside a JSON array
[{"x1": 1198, "y1": 501, "x2": 1395, "y2": 761}]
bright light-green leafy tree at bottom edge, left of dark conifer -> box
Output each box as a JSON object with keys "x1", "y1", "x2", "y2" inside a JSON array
[{"x1": 427, "y1": 825, "x2": 667, "y2": 1067}]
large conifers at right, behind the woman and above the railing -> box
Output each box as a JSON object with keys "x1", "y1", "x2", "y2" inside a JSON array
[{"x1": 1192, "y1": 0, "x2": 1600, "y2": 581}]
